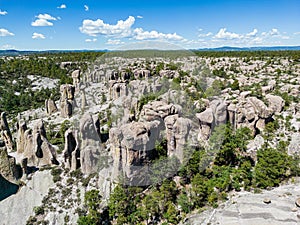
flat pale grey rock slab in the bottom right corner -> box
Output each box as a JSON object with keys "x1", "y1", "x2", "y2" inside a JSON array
[{"x1": 184, "y1": 184, "x2": 300, "y2": 225}]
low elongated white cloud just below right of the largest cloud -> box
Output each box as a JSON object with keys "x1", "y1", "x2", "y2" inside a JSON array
[{"x1": 134, "y1": 28, "x2": 183, "y2": 41}]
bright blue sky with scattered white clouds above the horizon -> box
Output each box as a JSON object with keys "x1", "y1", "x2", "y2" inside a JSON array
[{"x1": 0, "y1": 0, "x2": 300, "y2": 50}]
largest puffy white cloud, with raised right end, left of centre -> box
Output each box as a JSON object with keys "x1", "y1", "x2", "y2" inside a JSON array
[{"x1": 79, "y1": 16, "x2": 135, "y2": 37}]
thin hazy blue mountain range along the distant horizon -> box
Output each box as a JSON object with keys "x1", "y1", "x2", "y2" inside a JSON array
[{"x1": 0, "y1": 46, "x2": 300, "y2": 56}]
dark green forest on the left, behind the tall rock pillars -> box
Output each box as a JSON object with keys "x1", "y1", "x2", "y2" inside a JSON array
[{"x1": 0, "y1": 52, "x2": 103, "y2": 115}]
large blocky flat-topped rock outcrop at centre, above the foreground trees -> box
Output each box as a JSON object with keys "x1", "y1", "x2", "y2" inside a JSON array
[{"x1": 109, "y1": 121, "x2": 160, "y2": 182}]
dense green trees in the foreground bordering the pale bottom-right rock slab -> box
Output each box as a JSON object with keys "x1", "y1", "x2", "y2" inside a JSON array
[{"x1": 74, "y1": 123, "x2": 299, "y2": 224}]
